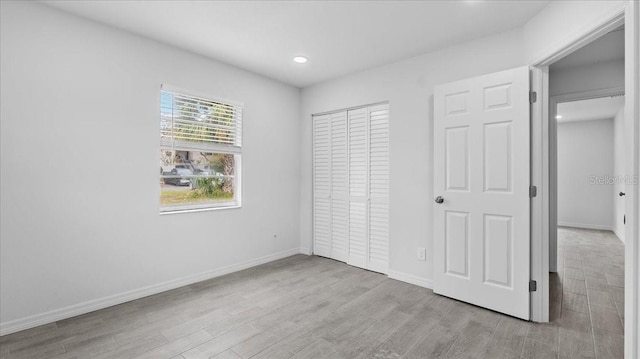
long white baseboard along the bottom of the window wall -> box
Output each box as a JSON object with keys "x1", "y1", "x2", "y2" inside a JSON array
[{"x1": 0, "y1": 248, "x2": 301, "y2": 336}]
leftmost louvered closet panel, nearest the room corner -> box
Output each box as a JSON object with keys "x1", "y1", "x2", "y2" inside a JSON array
[{"x1": 313, "y1": 115, "x2": 332, "y2": 257}]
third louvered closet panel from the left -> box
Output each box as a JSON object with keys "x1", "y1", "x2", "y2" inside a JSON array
[{"x1": 347, "y1": 108, "x2": 369, "y2": 268}]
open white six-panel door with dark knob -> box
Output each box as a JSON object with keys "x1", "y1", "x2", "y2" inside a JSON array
[{"x1": 434, "y1": 67, "x2": 530, "y2": 320}]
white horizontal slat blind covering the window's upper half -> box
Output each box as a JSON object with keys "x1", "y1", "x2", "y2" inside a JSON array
[{"x1": 160, "y1": 89, "x2": 242, "y2": 153}]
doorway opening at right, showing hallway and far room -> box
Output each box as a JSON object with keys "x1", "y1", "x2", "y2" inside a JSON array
[{"x1": 548, "y1": 26, "x2": 630, "y2": 356}]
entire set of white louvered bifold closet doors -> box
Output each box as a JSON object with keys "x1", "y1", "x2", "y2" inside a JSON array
[{"x1": 313, "y1": 104, "x2": 389, "y2": 273}]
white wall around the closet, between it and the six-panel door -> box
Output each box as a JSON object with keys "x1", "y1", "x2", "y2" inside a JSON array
[{"x1": 300, "y1": 30, "x2": 524, "y2": 285}]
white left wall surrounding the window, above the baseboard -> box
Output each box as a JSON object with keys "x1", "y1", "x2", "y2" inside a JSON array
[{"x1": 0, "y1": 1, "x2": 300, "y2": 333}]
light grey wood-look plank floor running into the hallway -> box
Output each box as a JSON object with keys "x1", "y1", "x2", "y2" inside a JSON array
[{"x1": 0, "y1": 228, "x2": 624, "y2": 359}]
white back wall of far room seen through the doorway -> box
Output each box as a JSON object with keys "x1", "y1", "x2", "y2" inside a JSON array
[{"x1": 558, "y1": 119, "x2": 613, "y2": 229}]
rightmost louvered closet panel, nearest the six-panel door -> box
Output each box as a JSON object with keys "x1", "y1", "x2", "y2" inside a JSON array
[{"x1": 368, "y1": 104, "x2": 389, "y2": 273}]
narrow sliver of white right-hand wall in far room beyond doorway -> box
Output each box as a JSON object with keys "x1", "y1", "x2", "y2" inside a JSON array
[{"x1": 613, "y1": 107, "x2": 627, "y2": 242}]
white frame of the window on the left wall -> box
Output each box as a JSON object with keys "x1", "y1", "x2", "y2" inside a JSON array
[{"x1": 156, "y1": 84, "x2": 244, "y2": 215}]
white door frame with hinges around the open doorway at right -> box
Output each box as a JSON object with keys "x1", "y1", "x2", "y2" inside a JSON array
[{"x1": 530, "y1": 1, "x2": 640, "y2": 358}]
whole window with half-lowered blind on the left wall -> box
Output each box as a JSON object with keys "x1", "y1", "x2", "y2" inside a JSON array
[{"x1": 160, "y1": 86, "x2": 242, "y2": 212}]
